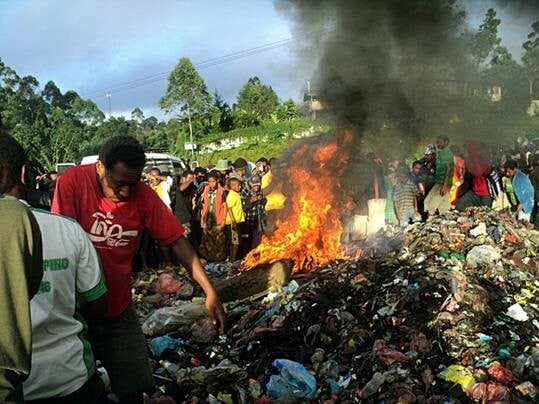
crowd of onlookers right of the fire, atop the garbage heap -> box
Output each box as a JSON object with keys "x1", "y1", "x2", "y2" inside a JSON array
[{"x1": 344, "y1": 136, "x2": 539, "y2": 240}]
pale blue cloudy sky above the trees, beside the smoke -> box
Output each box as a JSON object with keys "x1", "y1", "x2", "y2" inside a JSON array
[{"x1": 0, "y1": 0, "x2": 533, "y2": 117}]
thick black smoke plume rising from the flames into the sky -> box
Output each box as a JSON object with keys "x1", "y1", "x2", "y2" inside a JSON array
[{"x1": 275, "y1": 0, "x2": 539, "y2": 221}]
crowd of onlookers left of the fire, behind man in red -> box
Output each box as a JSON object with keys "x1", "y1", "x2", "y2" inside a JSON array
[{"x1": 135, "y1": 157, "x2": 283, "y2": 268}]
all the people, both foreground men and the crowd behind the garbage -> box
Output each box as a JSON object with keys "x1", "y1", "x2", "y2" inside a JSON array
[{"x1": 0, "y1": 131, "x2": 539, "y2": 403}]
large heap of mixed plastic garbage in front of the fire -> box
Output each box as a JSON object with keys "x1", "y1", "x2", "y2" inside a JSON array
[{"x1": 136, "y1": 209, "x2": 539, "y2": 403}]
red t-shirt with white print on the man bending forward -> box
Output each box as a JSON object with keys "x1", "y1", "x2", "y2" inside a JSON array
[{"x1": 52, "y1": 164, "x2": 184, "y2": 317}]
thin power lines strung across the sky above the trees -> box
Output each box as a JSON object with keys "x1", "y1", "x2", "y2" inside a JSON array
[{"x1": 81, "y1": 26, "x2": 335, "y2": 98}]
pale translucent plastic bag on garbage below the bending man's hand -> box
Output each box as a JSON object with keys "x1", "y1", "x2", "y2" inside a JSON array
[{"x1": 142, "y1": 302, "x2": 207, "y2": 336}]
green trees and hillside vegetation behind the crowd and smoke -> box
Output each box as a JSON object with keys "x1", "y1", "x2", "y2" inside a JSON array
[{"x1": 0, "y1": 9, "x2": 539, "y2": 171}]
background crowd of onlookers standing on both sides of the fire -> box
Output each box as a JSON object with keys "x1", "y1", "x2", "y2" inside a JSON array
[{"x1": 134, "y1": 136, "x2": 539, "y2": 266}]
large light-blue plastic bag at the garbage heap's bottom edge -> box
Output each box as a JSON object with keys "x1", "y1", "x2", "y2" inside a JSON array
[{"x1": 266, "y1": 359, "x2": 316, "y2": 402}]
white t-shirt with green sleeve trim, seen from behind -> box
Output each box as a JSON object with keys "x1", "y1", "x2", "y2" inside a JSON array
[{"x1": 23, "y1": 209, "x2": 107, "y2": 400}]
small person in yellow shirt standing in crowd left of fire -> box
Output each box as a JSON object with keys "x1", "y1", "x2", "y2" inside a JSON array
[{"x1": 225, "y1": 177, "x2": 245, "y2": 262}]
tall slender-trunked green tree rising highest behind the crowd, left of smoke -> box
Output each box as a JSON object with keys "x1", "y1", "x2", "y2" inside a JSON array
[{"x1": 159, "y1": 58, "x2": 211, "y2": 155}]
